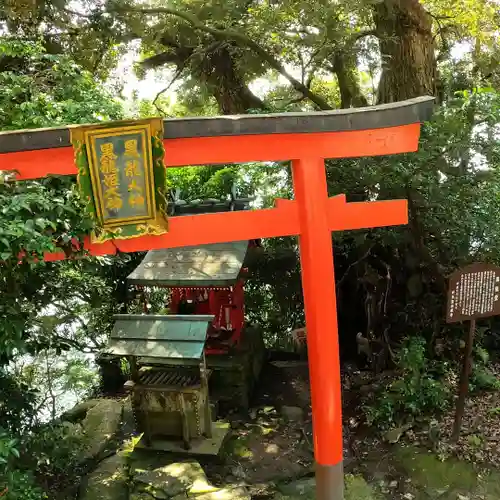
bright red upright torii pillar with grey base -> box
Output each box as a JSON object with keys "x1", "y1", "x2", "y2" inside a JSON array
[{"x1": 292, "y1": 158, "x2": 344, "y2": 494}]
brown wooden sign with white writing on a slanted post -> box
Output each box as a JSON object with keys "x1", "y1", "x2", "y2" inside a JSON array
[{"x1": 446, "y1": 263, "x2": 500, "y2": 441}]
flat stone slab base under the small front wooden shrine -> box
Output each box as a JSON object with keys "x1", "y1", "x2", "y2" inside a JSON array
[{"x1": 136, "y1": 422, "x2": 230, "y2": 457}]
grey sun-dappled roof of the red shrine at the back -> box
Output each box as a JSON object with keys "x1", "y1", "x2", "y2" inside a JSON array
[{"x1": 127, "y1": 241, "x2": 248, "y2": 287}]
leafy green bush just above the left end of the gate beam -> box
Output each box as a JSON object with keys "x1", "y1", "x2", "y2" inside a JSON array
[{"x1": 0, "y1": 37, "x2": 121, "y2": 130}]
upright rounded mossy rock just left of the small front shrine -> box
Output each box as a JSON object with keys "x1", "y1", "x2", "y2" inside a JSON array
[{"x1": 82, "y1": 399, "x2": 123, "y2": 458}]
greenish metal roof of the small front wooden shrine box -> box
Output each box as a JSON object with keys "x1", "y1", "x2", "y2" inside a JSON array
[{"x1": 104, "y1": 314, "x2": 214, "y2": 362}]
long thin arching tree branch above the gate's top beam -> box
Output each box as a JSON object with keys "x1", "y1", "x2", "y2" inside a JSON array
[{"x1": 114, "y1": 7, "x2": 333, "y2": 110}]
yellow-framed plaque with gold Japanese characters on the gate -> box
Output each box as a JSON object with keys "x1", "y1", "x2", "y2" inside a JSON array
[{"x1": 71, "y1": 119, "x2": 168, "y2": 241}]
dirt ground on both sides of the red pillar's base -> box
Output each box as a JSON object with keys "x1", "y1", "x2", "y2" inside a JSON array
[{"x1": 206, "y1": 361, "x2": 500, "y2": 500}]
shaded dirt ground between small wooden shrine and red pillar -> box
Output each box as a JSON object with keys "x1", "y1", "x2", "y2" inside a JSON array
[{"x1": 207, "y1": 361, "x2": 351, "y2": 488}]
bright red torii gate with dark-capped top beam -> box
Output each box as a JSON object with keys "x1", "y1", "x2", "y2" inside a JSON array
[{"x1": 0, "y1": 97, "x2": 433, "y2": 500}]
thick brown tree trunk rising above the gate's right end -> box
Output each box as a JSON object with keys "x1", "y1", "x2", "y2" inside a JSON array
[{"x1": 373, "y1": 0, "x2": 436, "y2": 103}]
